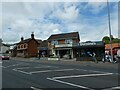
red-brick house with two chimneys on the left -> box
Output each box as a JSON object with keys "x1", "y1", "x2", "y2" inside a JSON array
[{"x1": 17, "y1": 33, "x2": 41, "y2": 57}]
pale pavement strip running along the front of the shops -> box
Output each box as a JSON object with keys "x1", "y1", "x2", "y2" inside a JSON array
[{"x1": 12, "y1": 57, "x2": 120, "y2": 69}]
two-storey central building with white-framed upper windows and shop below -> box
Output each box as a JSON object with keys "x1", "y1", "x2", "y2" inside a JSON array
[{"x1": 48, "y1": 32, "x2": 80, "y2": 58}]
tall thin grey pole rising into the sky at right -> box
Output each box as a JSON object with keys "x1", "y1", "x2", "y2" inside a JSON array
[{"x1": 107, "y1": 0, "x2": 113, "y2": 62}]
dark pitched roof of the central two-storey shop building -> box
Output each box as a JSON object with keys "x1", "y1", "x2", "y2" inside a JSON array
[{"x1": 48, "y1": 32, "x2": 79, "y2": 41}]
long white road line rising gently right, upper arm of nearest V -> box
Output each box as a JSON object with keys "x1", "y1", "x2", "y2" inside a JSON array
[{"x1": 53, "y1": 73, "x2": 113, "y2": 79}]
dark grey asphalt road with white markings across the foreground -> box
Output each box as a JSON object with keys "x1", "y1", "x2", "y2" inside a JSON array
[{"x1": 0, "y1": 58, "x2": 120, "y2": 90}]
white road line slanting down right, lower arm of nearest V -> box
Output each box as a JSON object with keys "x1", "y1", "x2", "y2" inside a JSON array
[{"x1": 47, "y1": 78, "x2": 94, "y2": 90}]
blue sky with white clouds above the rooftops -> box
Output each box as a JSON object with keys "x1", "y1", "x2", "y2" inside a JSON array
[{"x1": 0, "y1": 0, "x2": 118, "y2": 43}]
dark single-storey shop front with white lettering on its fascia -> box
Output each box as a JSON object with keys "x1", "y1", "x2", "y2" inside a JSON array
[{"x1": 74, "y1": 41, "x2": 105, "y2": 61}]
